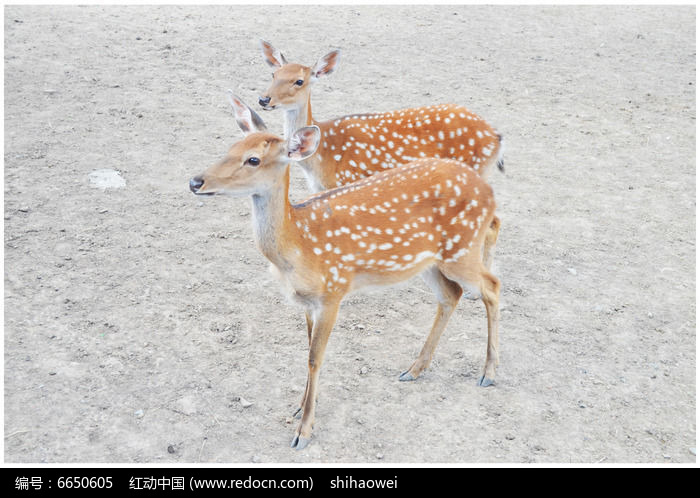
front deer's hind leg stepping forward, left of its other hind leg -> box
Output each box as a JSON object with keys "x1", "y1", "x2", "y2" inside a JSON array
[{"x1": 399, "y1": 266, "x2": 462, "y2": 381}]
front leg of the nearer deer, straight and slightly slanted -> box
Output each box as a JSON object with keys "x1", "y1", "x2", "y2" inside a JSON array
[{"x1": 291, "y1": 302, "x2": 340, "y2": 450}]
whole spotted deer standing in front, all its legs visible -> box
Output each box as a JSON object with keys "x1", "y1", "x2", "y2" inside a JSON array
[{"x1": 190, "y1": 97, "x2": 500, "y2": 449}]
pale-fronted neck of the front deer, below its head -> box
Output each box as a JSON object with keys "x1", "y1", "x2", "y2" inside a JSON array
[{"x1": 253, "y1": 166, "x2": 296, "y2": 270}]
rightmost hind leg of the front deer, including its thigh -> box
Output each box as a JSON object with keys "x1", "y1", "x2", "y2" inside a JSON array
[{"x1": 440, "y1": 256, "x2": 501, "y2": 387}]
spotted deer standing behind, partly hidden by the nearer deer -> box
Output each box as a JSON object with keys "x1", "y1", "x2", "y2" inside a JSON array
[{"x1": 259, "y1": 40, "x2": 503, "y2": 192}]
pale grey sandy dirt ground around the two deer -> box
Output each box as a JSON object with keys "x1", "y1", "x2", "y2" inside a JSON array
[{"x1": 4, "y1": 6, "x2": 696, "y2": 464}]
